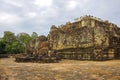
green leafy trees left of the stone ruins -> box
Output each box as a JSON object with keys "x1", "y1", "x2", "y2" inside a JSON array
[{"x1": 0, "y1": 31, "x2": 37, "y2": 54}]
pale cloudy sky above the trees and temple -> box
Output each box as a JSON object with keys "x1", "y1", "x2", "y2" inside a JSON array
[{"x1": 0, "y1": 0, "x2": 120, "y2": 37}]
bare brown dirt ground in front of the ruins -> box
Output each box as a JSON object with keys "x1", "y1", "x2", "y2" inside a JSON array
[{"x1": 0, "y1": 58, "x2": 120, "y2": 80}]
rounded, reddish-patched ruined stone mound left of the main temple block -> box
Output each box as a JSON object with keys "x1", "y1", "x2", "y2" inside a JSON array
[{"x1": 26, "y1": 36, "x2": 49, "y2": 55}]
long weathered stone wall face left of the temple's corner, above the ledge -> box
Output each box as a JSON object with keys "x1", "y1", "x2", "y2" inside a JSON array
[{"x1": 49, "y1": 26, "x2": 93, "y2": 50}]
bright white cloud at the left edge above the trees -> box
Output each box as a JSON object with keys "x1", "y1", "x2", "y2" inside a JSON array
[{"x1": 0, "y1": 12, "x2": 21, "y2": 25}]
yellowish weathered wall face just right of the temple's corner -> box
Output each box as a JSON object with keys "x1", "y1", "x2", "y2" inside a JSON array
[{"x1": 94, "y1": 26, "x2": 109, "y2": 48}]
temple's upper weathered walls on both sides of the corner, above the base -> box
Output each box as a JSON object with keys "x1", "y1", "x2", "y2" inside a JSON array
[{"x1": 49, "y1": 19, "x2": 109, "y2": 50}]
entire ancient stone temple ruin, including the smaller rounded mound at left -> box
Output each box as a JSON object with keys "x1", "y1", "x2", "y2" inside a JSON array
[{"x1": 16, "y1": 16, "x2": 120, "y2": 62}]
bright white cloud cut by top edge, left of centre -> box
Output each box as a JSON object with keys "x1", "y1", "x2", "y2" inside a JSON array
[{"x1": 34, "y1": 0, "x2": 53, "y2": 7}]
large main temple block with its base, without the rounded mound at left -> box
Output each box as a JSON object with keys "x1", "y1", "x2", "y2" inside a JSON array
[{"x1": 48, "y1": 16, "x2": 120, "y2": 60}]
